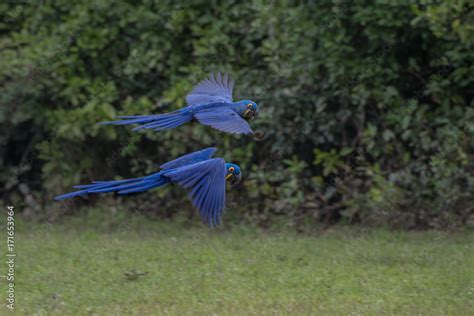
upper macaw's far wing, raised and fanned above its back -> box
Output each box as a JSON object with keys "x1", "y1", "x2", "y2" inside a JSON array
[{"x1": 186, "y1": 73, "x2": 234, "y2": 105}]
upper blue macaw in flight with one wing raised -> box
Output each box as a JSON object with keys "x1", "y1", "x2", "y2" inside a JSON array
[{"x1": 100, "y1": 73, "x2": 258, "y2": 134}]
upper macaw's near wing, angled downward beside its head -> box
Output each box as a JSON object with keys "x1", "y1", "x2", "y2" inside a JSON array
[{"x1": 194, "y1": 108, "x2": 253, "y2": 134}]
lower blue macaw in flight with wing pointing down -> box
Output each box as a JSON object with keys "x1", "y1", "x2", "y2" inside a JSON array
[{"x1": 54, "y1": 147, "x2": 242, "y2": 226}]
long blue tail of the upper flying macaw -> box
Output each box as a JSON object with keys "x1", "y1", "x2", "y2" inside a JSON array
[{"x1": 99, "y1": 109, "x2": 193, "y2": 131}]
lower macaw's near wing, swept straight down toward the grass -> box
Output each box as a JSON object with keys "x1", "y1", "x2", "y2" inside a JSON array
[{"x1": 166, "y1": 158, "x2": 227, "y2": 226}]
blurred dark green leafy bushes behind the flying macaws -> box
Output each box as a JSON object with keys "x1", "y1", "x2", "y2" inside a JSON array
[{"x1": 0, "y1": 0, "x2": 474, "y2": 229}]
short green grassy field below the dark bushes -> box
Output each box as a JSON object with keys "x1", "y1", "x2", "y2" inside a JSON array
[{"x1": 1, "y1": 211, "x2": 474, "y2": 315}]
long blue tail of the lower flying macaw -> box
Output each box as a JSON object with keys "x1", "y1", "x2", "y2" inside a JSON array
[{"x1": 54, "y1": 172, "x2": 169, "y2": 201}]
